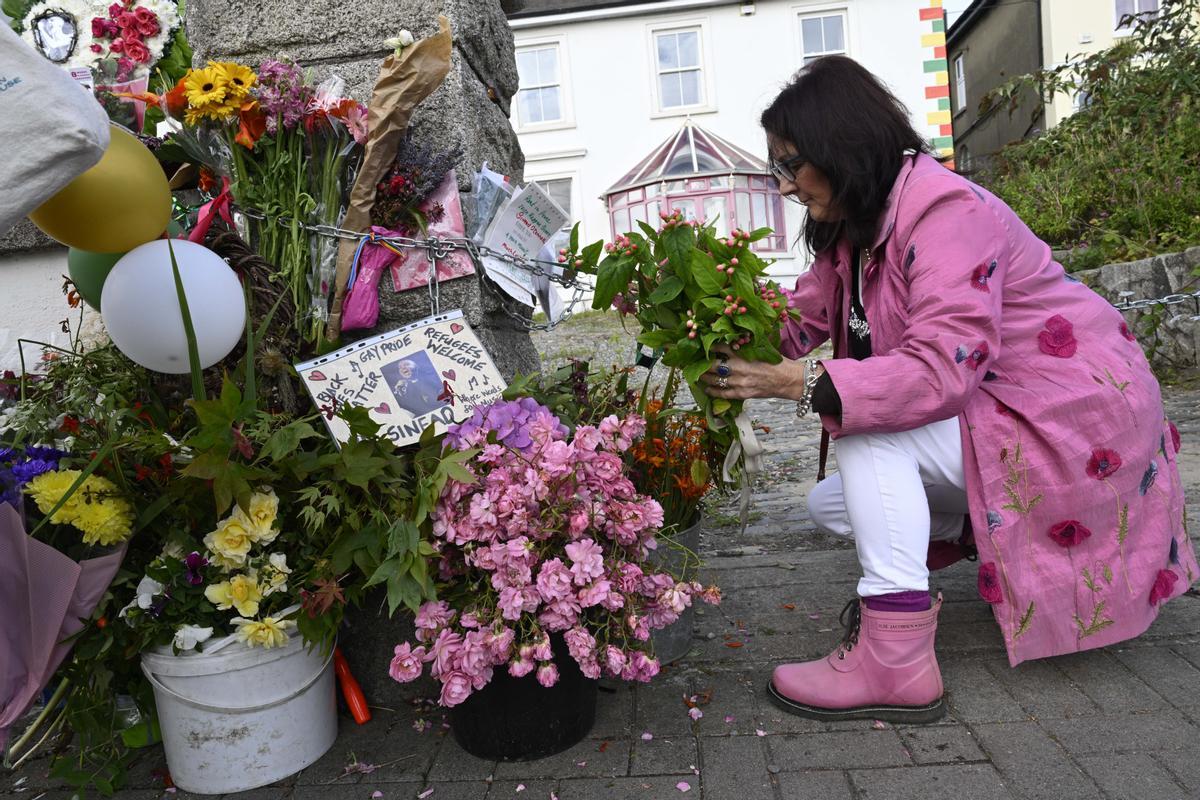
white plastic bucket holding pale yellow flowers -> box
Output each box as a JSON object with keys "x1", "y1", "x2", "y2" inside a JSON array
[{"x1": 142, "y1": 636, "x2": 337, "y2": 794}]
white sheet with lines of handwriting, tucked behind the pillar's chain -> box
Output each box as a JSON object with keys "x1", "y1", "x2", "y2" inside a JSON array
[{"x1": 484, "y1": 184, "x2": 568, "y2": 306}]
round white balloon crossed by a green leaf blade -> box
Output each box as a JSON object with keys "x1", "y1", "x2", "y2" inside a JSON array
[{"x1": 100, "y1": 239, "x2": 246, "y2": 374}]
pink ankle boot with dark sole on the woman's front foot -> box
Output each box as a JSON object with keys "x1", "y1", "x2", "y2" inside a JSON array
[{"x1": 767, "y1": 595, "x2": 946, "y2": 723}]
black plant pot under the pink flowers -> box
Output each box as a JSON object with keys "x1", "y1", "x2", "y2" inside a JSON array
[{"x1": 450, "y1": 633, "x2": 598, "y2": 762}]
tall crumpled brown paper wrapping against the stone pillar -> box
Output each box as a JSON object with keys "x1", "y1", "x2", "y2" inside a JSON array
[{"x1": 325, "y1": 16, "x2": 452, "y2": 341}]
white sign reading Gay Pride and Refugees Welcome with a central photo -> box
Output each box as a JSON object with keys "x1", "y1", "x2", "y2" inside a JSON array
[{"x1": 296, "y1": 311, "x2": 505, "y2": 446}]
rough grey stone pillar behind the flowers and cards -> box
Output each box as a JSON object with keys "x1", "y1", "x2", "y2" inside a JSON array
[{"x1": 187, "y1": 0, "x2": 539, "y2": 705}]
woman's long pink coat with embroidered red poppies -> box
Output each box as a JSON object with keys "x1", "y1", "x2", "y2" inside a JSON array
[{"x1": 784, "y1": 155, "x2": 1200, "y2": 666}]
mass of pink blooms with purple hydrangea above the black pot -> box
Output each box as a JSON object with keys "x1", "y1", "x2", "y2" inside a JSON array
[{"x1": 390, "y1": 398, "x2": 720, "y2": 706}]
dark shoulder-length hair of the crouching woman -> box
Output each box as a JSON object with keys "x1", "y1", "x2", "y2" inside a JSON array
[{"x1": 761, "y1": 55, "x2": 929, "y2": 253}]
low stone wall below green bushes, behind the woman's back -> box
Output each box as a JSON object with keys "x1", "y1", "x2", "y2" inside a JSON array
[{"x1": 1075, "y1": 247, "x2": 1200, "y2": 369}]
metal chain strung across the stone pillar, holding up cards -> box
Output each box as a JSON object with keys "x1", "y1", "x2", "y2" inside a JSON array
[{"x1": 236, "y1": 206, "x2": 592, "y2": 331}]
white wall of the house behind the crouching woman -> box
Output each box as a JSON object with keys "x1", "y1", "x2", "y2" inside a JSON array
[{"x1": 512, "y1": 0, "x2": 938, "y2": 286}]
